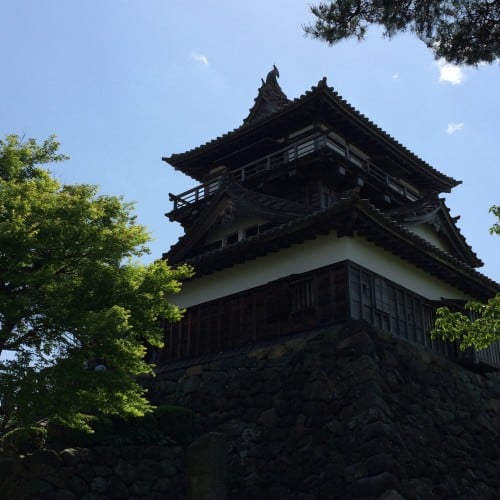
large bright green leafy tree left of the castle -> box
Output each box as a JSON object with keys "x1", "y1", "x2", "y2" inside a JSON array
[{"x1": 0, "y1": 135, "x2": 191, "y2": 430}]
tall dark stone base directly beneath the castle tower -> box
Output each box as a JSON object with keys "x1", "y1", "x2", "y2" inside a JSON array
[{"x1": 155, "y1": 322, "x2": 500, "y2": 500}]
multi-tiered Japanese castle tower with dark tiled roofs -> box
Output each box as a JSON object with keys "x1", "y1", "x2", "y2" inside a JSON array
[{"x1": 157, "y1": 67, "x2": 500, "y2": 368}]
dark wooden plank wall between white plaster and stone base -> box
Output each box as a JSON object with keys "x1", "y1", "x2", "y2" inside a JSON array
[{"x1": 158, "y1": 261, "x2": 500, "y2": 368}]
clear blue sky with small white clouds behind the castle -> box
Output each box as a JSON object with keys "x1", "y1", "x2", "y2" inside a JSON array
[{"x1": 0, "y1": 0, "x2": 500, "y2": 281}]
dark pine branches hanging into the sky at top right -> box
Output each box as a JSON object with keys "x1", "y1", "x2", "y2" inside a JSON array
[{"x1": 304, "y1": 0, "x2": 500, "y2": 65}]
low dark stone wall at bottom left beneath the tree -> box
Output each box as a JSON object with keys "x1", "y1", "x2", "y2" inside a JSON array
[{"x1": 0, "y1": 446, "x2": 186, "y2": 500}]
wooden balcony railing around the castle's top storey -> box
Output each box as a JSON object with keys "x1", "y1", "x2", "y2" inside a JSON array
[{"x1": 169, "y1": 132, "x2": 419, "y2": 211}]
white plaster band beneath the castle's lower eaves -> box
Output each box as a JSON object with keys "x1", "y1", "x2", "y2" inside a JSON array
[{"x1": 173, "y1": 231, "x2": 470, "y2": 307}]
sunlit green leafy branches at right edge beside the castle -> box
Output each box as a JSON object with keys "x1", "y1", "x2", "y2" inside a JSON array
[{"x1": 431, "y1": 206, "x2": 500, "y2": 350}]
